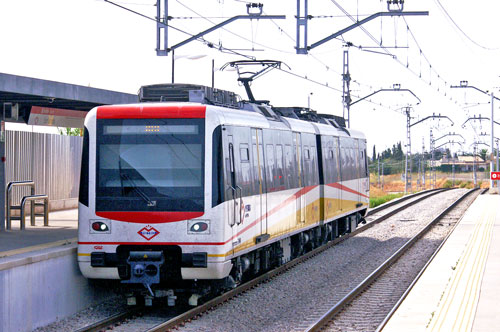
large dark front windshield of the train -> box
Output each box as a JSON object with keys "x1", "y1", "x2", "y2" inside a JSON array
[{"x1": 96, "y1": 119, "x2": 204, "y2": 212}]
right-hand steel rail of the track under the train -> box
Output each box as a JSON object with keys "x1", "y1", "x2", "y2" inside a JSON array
[{"x1": 147, "y1": 189, "x2": 449, "y2": 332}]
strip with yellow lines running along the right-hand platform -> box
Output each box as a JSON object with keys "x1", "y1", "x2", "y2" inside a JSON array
[{"x1": 429, "y1": 198, "x2": 496, "y2": 331}]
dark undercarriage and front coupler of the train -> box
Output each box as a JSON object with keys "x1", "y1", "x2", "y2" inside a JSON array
[{"x1": 108, "y1": 210, "x2": 366, "y2": 306}]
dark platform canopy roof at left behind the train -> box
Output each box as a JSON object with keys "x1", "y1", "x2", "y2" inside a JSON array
[{"x1": 0, "y1": 73, "x2": 139, "y2": 122}]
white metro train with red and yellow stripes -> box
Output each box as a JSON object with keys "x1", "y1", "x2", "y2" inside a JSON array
[{"x1": 78, "y1": 84, "x2": 369, "y2": 305}]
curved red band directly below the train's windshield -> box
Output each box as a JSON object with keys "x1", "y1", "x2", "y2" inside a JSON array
[{"x1": 95, "y1": 211, "x2": 204, "y2": 224}]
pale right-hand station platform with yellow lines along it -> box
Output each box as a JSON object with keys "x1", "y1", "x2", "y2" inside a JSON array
[{"x1": 382, "y1": 194, "x2": 500, "y2": 332}]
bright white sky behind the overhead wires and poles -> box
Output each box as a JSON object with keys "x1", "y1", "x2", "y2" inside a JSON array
[{"x1": 0, "y1": 0, "x2": 500, "y2": 156}]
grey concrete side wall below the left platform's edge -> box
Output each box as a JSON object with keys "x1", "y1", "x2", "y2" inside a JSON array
[{"x1": 0, "y1": 244, "x2": 112, "y2": 332}]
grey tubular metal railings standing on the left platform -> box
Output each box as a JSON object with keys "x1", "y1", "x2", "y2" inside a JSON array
[{"x1": 5, "y1": 181, "x2": 49, "y2": 230}]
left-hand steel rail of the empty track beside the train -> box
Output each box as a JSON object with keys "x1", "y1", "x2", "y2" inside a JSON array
[{"x1": 305, "y1": 189, "x2": 477, "y2": 332}]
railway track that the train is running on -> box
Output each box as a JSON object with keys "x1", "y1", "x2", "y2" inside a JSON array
[{"x1": 72, "y1": 189, "x2": 458, "y2": 332}]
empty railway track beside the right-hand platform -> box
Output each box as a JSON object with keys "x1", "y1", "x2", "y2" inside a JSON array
[{"x1": 305, "y1": 190, "x2": 484, "y2": 332}]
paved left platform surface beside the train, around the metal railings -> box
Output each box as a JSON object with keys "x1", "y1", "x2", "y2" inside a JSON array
[{"x1": 0, "y1": 209, "x2": 78, "y2": 258}]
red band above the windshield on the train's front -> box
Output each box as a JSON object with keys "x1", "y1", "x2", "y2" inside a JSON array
[{"x1": 97, "y1": 104, "x2": 207, "y2": 119}]
